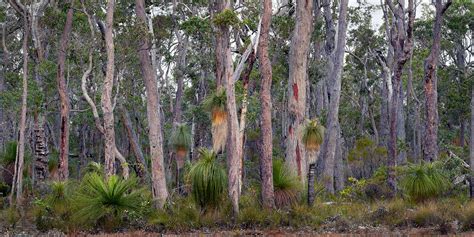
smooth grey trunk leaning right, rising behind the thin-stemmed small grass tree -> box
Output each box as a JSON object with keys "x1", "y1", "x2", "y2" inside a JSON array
[{"x1": 321, "y1": 0, "x2": 348, "y2": 193}]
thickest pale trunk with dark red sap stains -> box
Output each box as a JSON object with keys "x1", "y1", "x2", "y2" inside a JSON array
[{"x1": 285, "y1": 0, "x2": 313, "y2": 183}]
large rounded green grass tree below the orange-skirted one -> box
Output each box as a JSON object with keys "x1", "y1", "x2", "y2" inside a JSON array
[{"x1": 188, "y1": 148, "x2": 227, "y2": 208}]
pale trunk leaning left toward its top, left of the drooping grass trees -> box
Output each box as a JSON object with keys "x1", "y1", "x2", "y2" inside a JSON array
[{"x1": 135, "y1": 0, "x2": 168, "y2": 208}]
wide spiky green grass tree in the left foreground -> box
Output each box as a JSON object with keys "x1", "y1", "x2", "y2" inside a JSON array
[{"x1": 74, "y1": 173, "x2": 148, "y2": 230}]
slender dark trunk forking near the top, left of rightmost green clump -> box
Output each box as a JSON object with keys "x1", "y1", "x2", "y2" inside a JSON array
[{"x1": 387, "y1": 0, "x2": 415, "y2": 195}]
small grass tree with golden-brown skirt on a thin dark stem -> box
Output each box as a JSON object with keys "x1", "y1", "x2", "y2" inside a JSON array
[{"x1": 302, "y1": 119, "x2": 324, "y2": 205}]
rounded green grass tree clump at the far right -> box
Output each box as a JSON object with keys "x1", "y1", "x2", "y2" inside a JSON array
[{"x1": 401, "y1": 162, "x2": 449, "y2": 202}]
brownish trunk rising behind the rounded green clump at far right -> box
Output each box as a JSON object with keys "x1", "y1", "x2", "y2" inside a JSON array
[{"x1": 423, "y1": 0, "x2": 452, "y2": 161}]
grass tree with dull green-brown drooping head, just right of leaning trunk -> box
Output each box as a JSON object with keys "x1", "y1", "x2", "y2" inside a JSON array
[{"x1": 171, "y1": 123, "x2": 191, "y2": 192}]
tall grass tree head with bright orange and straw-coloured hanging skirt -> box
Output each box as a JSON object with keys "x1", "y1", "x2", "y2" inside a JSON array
[{"x1": 203, "y1": 88, "x2": 227, "y2": 152}]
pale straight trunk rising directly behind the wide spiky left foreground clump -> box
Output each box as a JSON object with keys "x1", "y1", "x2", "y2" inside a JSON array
[{"x1": 101, "y1": 0, "x2": 115, "y2": 177}]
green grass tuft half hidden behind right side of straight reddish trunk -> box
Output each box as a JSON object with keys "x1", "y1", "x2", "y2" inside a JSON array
[{"x1": 273, "y1": 159, "x2": 301, "y2": 208}]
